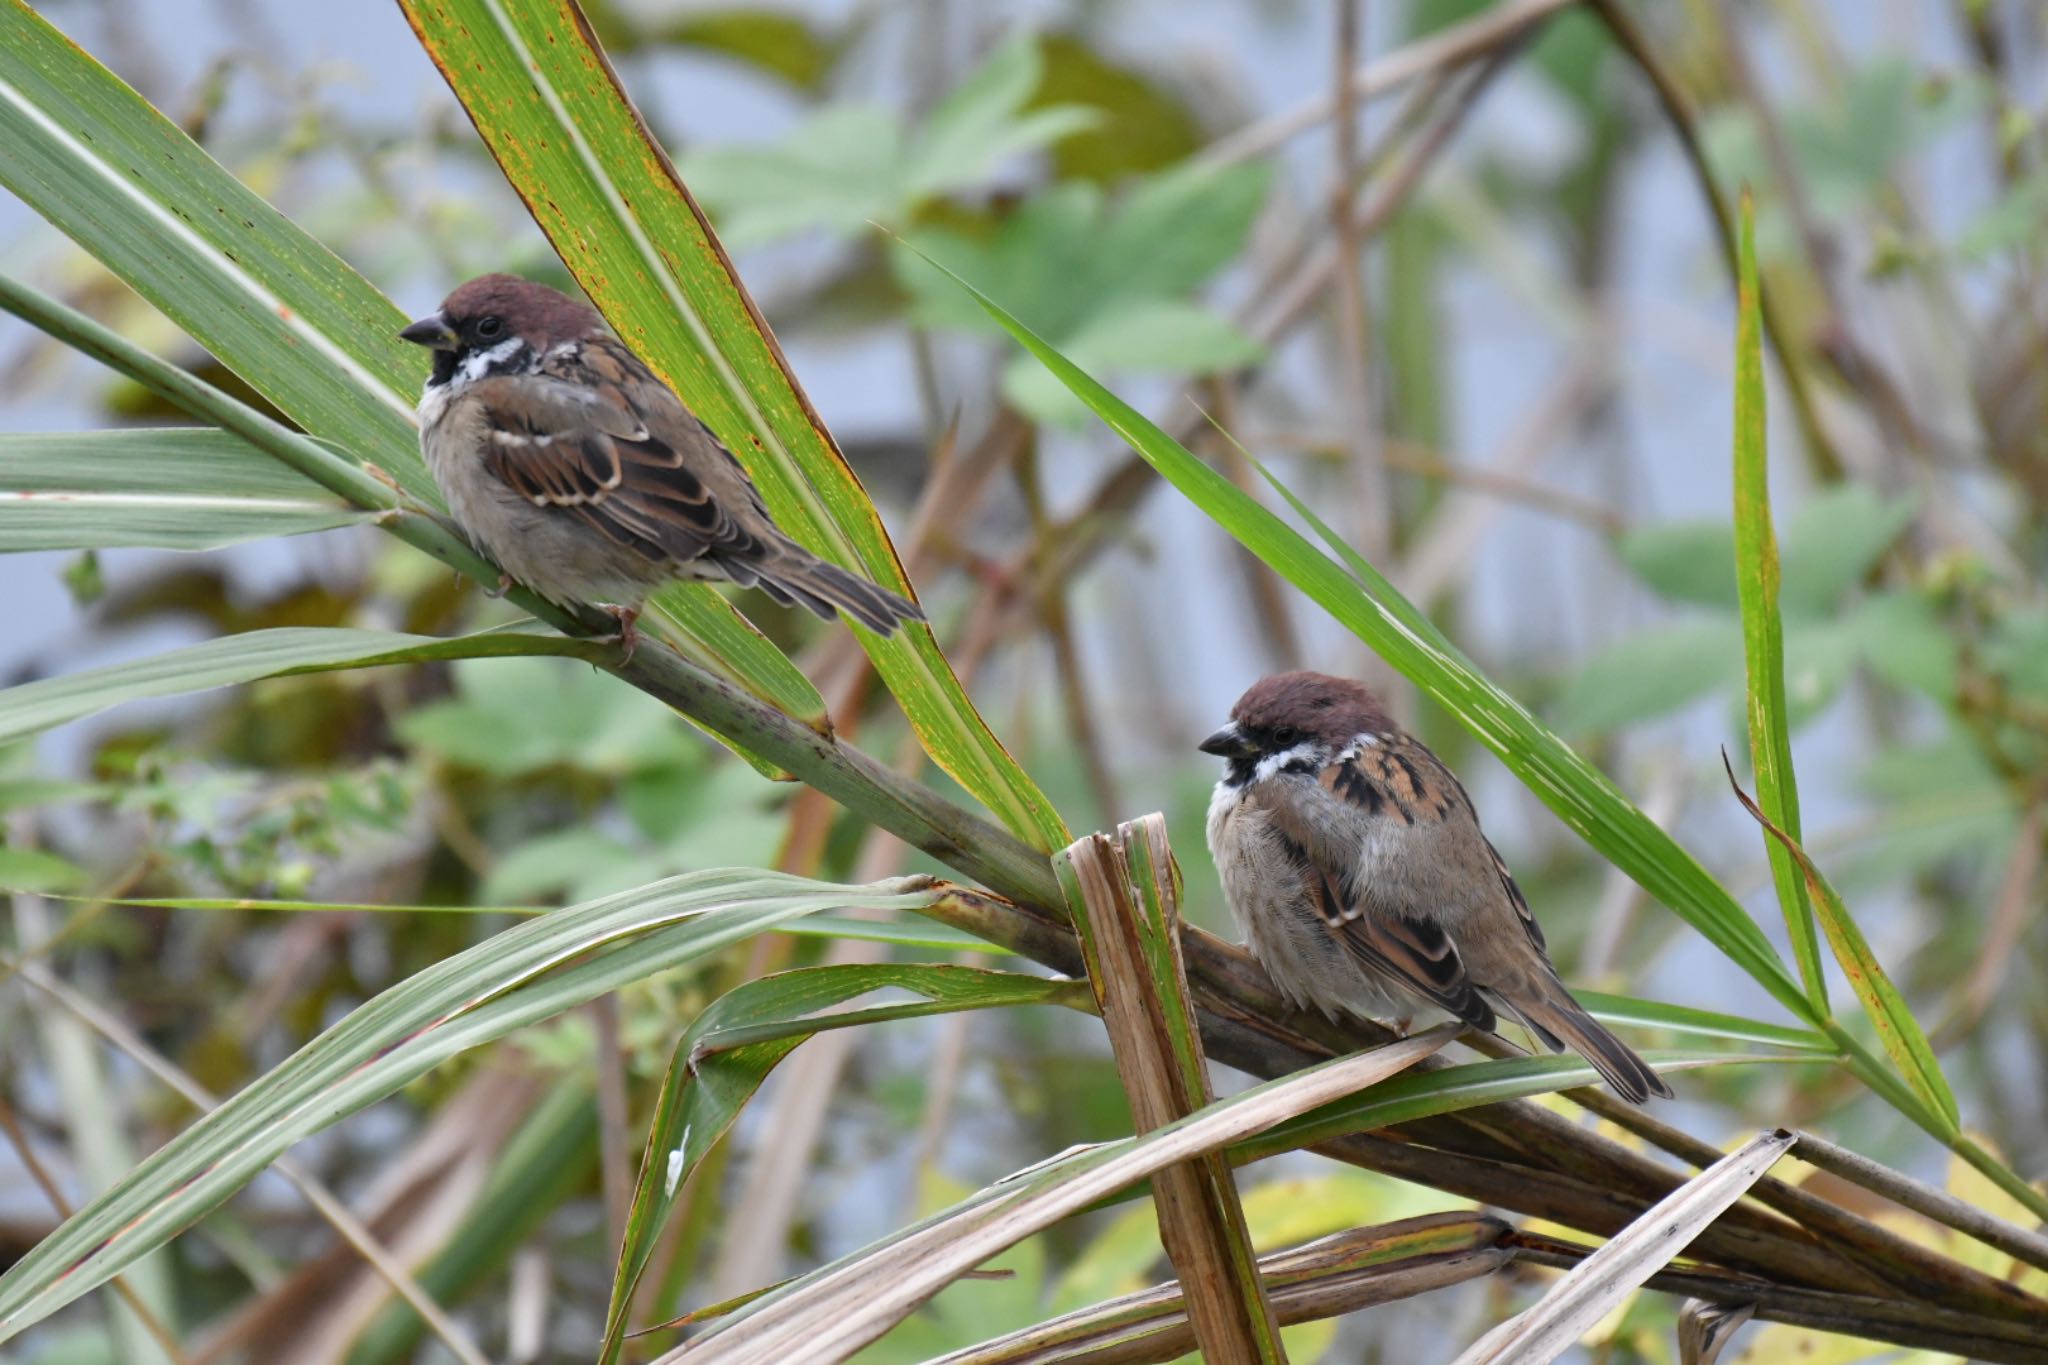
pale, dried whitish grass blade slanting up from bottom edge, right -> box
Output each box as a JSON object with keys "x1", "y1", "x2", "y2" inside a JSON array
[{"x1": 1456, "y1": 1128, "x2": 1794, "y2": 1365}]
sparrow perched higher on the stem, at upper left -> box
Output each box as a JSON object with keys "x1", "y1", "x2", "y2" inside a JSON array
[{"x1": 399, "y1": 274, "x2": 924, "y2": 653}]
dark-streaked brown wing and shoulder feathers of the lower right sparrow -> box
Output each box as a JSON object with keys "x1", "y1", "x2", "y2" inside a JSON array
[{"x1": 1262, "y1": 749, "x2": 1495, "y2": 1029}]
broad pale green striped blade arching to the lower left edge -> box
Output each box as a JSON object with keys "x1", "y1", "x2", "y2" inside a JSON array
[{"x1": 0, "y1": 870, "x2": 940, "y2": 1340}]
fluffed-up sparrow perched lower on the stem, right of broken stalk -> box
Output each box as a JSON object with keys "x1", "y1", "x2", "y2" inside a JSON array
[{"x1": 1202, "y1": 673, "x2": 1671, "y2": 1105}]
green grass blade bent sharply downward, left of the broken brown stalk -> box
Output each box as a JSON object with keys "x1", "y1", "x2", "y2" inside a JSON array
[{"x1": 598, "y1": 962, "x2": 1087, "y2": 1365}]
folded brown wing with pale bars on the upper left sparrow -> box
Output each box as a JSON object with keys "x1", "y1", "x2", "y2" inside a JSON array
[{"x1": 471, "y1": 342, "x2": 780, "y2": 577}]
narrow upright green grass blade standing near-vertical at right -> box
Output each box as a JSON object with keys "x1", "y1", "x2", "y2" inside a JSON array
[{"x1": 1735, "y1": 194, "x2": 1829, "y2": 1019}]
